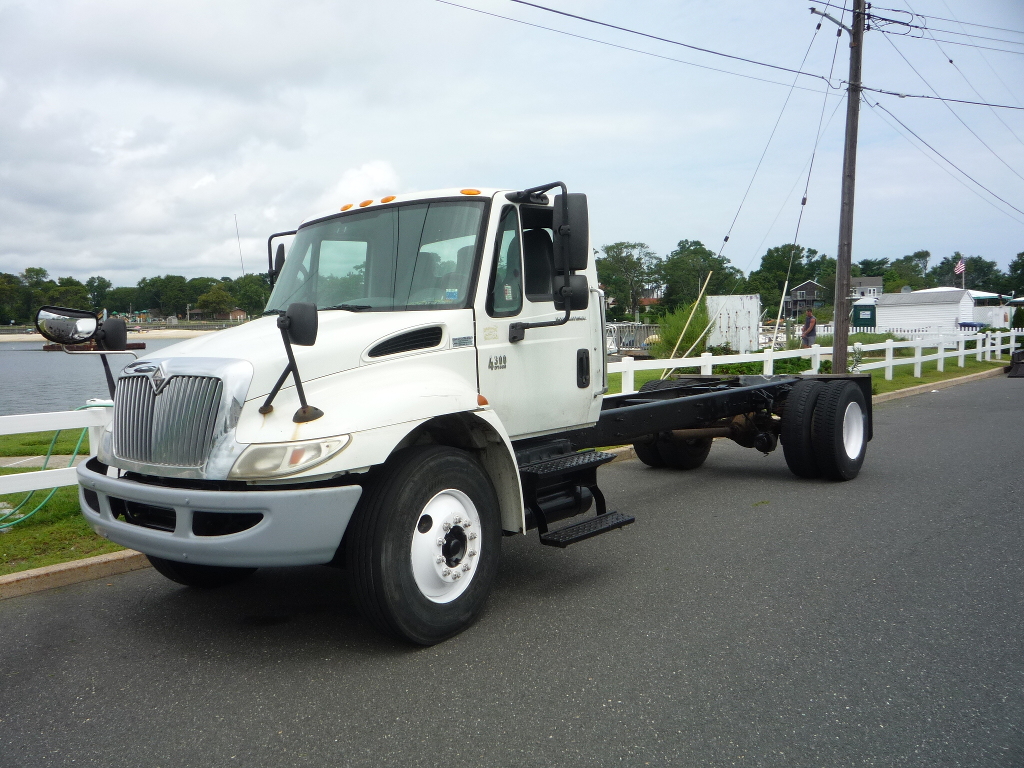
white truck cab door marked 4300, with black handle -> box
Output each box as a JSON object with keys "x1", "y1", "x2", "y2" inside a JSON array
[{"x1": 476, "y1": 201, "x2": 603, "y2": 438}]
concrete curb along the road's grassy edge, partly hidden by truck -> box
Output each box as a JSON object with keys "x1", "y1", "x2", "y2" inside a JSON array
[{"x1": 0, "y1": 367, "x2": 1007, "y2": 600}]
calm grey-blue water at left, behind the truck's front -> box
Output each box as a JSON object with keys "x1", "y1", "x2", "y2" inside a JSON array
[{"x1": 0, "y1": 339, "x2": 183, "y2": 416}]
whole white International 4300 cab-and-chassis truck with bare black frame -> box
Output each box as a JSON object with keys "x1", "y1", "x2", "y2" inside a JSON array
[{"x1": 37, "y1": 182, "x2": 871, "y2": 644}]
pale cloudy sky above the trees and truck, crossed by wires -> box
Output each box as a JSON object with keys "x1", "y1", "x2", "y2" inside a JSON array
[{"x1": 0, "y1": 0, "x2": 1024, "y2": 285}]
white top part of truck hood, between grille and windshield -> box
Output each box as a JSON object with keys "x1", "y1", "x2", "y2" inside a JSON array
[{"x1": 145, "y1": 309, "x2": 473, "y2": 401}]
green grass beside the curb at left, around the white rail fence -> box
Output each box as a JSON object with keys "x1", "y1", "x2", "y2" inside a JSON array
[{"x1": 0, "y1": 469, "x2": 123, "y2": 575}]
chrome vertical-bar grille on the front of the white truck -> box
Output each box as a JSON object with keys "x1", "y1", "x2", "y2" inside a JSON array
[{"x1": 114, "y1": 376, "x2": 222, "y2": 467}]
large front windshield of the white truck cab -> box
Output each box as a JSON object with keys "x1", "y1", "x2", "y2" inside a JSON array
[{"x1": 266, "y1": 201, "x2": 486, "y2": 312}]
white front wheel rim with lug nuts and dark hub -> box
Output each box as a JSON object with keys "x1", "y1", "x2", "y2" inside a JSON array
[{"x1": 411, "y1": 488, "x2": 481, "y2": 603}]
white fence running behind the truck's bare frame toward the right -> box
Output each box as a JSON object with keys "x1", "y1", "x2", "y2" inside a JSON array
[{"x1": 608, "y1": 328, "x2": 1024, "y2": 394}]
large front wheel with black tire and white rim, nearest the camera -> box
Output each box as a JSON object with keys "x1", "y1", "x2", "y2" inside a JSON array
[{"x1": 345, "y1": 445, "x2": 502, "y2": 645}]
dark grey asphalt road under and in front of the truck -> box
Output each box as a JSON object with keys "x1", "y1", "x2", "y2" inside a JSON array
[{"x1": 0, "y1": 379, "x2": 1024, "y2": 768}]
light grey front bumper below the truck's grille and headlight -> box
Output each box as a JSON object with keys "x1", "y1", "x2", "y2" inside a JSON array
[{"x1": 78, "y1": 460, "x2": 362, "y2": 567}]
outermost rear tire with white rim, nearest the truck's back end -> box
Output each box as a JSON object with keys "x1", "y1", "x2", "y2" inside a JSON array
[{"x1": 811, "y1": 380, "x2": 867, "y2": 480}]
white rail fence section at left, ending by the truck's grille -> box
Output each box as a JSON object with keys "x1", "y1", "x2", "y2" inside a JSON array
[{"x1": 0, "y1": 399, "x2": 113, "y2": 496}]
